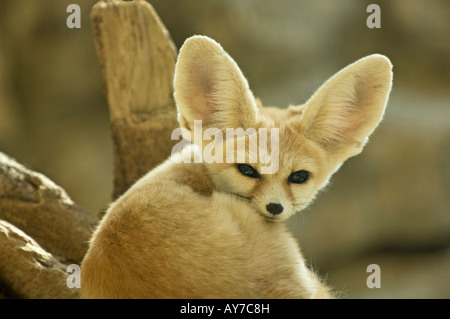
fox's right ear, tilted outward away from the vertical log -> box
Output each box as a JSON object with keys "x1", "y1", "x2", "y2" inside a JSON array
[{"x1": 301, "y1": 54, "x2": 392, "y2": 165}]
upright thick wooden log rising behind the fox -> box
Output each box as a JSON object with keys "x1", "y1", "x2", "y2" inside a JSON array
[{"x1": 91, "y1": 0, "x2": 178, "y2": 198}]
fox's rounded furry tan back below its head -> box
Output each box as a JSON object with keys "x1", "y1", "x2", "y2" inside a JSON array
[{"x1": 82, "y1": 160, "x2": 326, "y2": 298}]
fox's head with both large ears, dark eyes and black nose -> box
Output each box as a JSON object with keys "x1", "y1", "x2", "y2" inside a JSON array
[{"x1": 174, "y1": 36, "x2": 392, "y2": 221}]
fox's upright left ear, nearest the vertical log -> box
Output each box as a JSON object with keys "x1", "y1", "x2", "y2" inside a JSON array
[{"x1": 174, "y1": 36, "x2": 257, "y2": 130}]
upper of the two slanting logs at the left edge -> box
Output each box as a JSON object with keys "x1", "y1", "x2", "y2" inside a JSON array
[{"x1": 0, "y1": 153, "x2": 98, "y2": 263}]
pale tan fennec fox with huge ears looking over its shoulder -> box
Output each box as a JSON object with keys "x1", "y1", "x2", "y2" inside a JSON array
[{"x1": 81, "y1": 36, "x2": 392, "y2": 298}]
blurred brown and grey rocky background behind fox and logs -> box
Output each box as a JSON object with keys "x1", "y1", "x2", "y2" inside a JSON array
[{"x1": 0, "y1": 0, "x2": 450, "y2": 298}]
